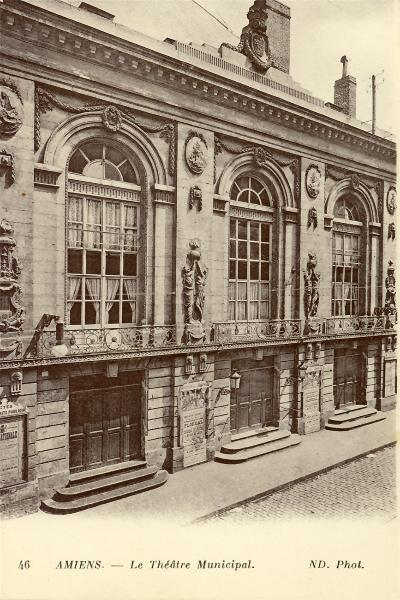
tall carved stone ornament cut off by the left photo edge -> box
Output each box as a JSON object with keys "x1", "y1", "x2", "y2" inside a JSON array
[{"x1": 0, "y1": 219, "x2": 25, "y2": 333}]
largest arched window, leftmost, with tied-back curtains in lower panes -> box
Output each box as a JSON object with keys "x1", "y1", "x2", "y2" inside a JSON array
[{"x1": 67, "y1": 141, "x2": 140, "y2": 327}]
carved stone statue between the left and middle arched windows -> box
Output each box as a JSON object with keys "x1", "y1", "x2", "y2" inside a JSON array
[{"x1": 182, "y1": 239, "x2": 207, "y2": 344}]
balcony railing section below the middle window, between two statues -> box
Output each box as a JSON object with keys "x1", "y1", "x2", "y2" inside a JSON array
[{"x1": 213, "y1": 319, "x2": 301, "y2": 344}]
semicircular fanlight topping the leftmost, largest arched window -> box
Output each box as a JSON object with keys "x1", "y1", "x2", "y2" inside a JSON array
[{"x1": 69, "y1": 141, "x2": 137, "y2": 183}]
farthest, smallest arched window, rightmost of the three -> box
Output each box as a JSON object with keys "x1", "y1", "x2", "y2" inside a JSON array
[{"x1": 332, "y1": 194, "x2": 366, "y2": 317}]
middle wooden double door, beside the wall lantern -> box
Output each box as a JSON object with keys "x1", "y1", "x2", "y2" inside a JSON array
[{"x1": 230, "y1": 357, "x2": 274, "y2": 433}]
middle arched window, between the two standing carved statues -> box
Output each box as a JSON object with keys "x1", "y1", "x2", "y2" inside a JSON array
[{"x1": 228, "y1": 175, "x2": 273, "y2": 321}]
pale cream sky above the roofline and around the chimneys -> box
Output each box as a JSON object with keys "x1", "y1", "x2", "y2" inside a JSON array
[{"x1": 61, "y1": 0, "x2": 400, "y2": 132}]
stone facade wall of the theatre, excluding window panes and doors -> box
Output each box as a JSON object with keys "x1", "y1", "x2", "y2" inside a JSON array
[{"x1": 0, "y1": 0, "x2": 396, "y2": 512}]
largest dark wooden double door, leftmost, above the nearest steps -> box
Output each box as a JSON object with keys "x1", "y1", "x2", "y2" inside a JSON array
[{"x1": 69, "y1": 373, "x2": 143, "y2": 473}]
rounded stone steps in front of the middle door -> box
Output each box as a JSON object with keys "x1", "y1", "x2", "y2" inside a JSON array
[{"x1": 215, "y1": 427, "x2": 300, "y2": 464}]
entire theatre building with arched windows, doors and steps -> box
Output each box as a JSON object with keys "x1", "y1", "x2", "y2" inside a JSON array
[{"x1": 0, "y1": 0, "x2": 396, "y2": 514}]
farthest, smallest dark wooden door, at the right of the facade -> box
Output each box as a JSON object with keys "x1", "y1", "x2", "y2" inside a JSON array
[{"x1": 333, "y1": 348, "x2": 364, "y2": 409}]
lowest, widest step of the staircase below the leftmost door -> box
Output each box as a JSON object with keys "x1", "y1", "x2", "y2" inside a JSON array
[{"x1": 42, "y1": 470, "x2": 168, "y2": 514}]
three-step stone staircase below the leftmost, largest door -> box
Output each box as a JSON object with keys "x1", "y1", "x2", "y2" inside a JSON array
[{"x1": 41, "y1": 460, "x2": 168, "y2": 514}]
